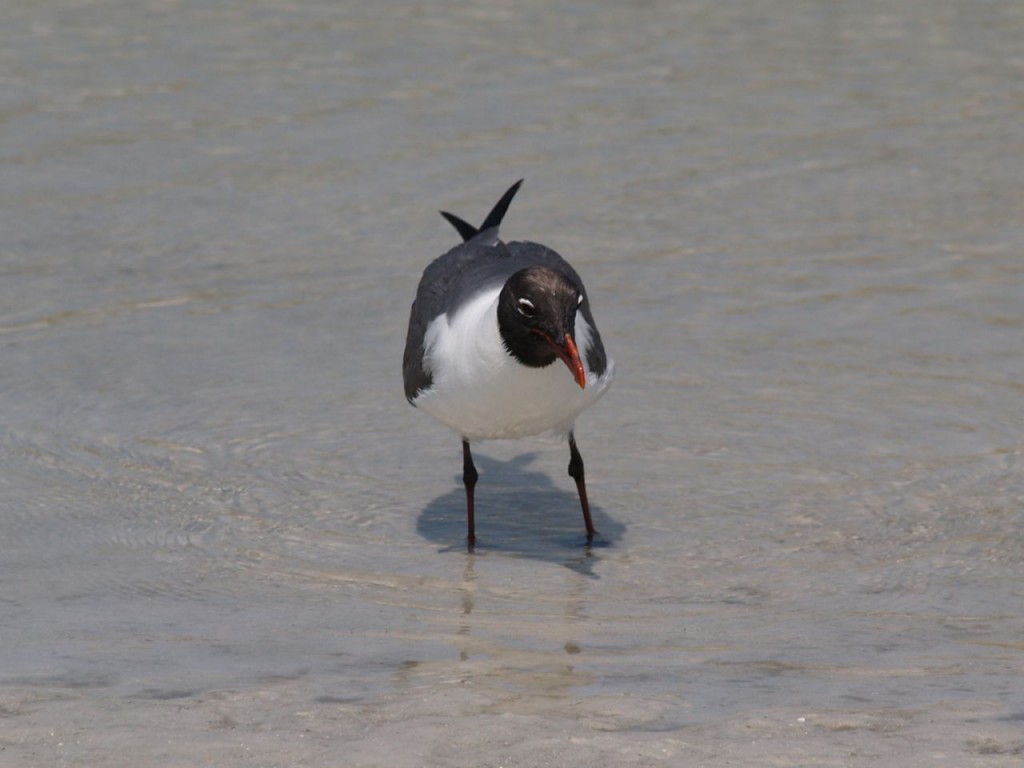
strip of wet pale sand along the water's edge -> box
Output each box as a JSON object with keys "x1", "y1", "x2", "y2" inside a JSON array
[{"x1": 0, "y1": 681, "x2": 1024, "y2": 768}]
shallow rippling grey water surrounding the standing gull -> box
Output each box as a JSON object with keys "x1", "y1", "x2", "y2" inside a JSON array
[{"x1": 0, "y1": 0, "x2": 1024, "y2": 753}]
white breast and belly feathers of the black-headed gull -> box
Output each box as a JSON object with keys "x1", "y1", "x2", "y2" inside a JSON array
[{"x1": 414, "y1": 289, "x2": 614, "y2": 440}]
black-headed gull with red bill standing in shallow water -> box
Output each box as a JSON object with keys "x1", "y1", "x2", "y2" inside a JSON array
[{"x1": 402, "y1": 179, "x2": 614, "y2": 547}]
